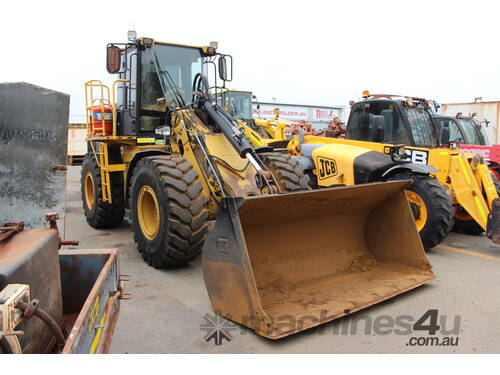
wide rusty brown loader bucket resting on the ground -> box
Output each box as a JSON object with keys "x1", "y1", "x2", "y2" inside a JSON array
[{"x1": 202, "y1": 181, "x2": 435, "y2": 339}]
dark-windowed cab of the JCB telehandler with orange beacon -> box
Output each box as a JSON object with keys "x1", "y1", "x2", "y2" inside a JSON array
[{"x1": 346, "y1": 95, "x2": 440, "y2": 148}]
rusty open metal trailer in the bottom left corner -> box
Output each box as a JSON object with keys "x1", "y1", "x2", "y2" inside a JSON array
[{"x1": 0, "y1": 228, "x2": 124, "y2": 354}]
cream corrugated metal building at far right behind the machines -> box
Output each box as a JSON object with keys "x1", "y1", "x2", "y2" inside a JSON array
[{"x1": 441, "y1": 101, "x2": 500, "y2": 144}]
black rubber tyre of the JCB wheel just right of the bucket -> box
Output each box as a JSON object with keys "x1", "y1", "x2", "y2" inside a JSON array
[{"x1": 389, "y1": 173, "x2": 454, "y2": 251}]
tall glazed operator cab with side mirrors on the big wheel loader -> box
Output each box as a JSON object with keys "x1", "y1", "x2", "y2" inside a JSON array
[{"x1": 107, "y1": 38, "x2": 232, "y2": 138}]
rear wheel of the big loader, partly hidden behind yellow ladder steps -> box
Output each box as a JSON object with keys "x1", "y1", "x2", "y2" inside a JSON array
[{"x1": 81, "y1": 153, "x2": 125, "y2": 229}]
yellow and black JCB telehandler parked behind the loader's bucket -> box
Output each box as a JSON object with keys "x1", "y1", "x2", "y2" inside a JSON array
[{"x1": 289, "y1": 94, "x2": 500, "y2": 249}]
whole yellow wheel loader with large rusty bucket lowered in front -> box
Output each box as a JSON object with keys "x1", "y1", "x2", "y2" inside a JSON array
[{"x1": 82, "y1": 37, "x2": 434, "y2": 339}]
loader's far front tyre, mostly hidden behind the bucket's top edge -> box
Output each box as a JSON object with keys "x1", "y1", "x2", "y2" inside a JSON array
[{"x1": 259, "y1": 152, "x2": 310, "y2": 191}]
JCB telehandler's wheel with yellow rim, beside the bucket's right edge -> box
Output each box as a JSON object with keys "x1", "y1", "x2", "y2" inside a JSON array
[{"x1": 389, "y1": 173, "x2": 453, "y2": 251}]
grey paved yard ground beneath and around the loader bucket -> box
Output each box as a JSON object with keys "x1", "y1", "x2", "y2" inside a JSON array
[{"x1": 65, "y1": 167, "x2": 500, "y2": 353}]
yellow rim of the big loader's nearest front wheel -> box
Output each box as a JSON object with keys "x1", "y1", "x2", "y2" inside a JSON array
[{"x1": 137, "y1": 185, "x2": 160, "y2": 240}]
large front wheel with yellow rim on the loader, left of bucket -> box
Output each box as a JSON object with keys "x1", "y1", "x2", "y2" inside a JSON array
[{"x1": 130, "y1": 156, "x2": 208, "y2": 268}]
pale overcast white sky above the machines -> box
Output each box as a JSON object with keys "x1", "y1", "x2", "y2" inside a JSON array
[{"x1": 0, "y1": 0, "x2": 500, "y2": 122}]
